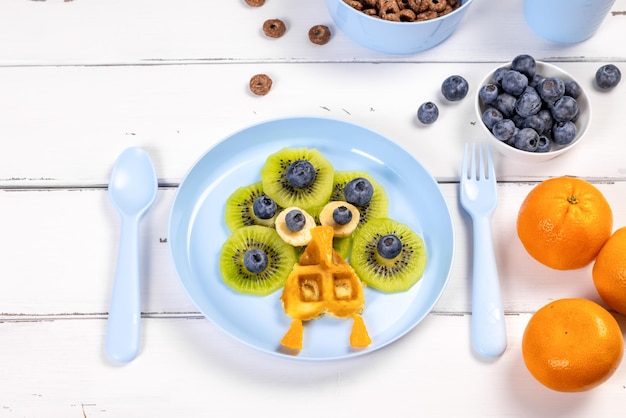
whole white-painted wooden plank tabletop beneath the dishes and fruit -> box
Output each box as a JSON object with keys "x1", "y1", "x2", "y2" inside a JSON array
[{"x1": 0, "y1": 0, "x2": 626, "y2": 417}]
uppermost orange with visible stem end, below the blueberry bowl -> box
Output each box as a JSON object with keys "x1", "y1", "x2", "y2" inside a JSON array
[{"x1": 517, "y1": 177, "x2": 613, "y2": 270}]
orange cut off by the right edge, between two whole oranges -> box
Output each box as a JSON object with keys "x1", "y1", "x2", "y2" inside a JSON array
[{"x1": 591, "y1": 227, "x2": 626, "y2": 315}]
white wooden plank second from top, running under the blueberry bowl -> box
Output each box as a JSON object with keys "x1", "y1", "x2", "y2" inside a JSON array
[{"x1": 0, "y1": 63, "x2": 626, "y2": 187}]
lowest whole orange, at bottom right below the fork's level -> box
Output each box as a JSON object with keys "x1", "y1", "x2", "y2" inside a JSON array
[{"x1": 522, "y1": 298, "x2": 624, "y2": 392}]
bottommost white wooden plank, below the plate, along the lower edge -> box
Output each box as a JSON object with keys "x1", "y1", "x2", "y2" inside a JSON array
[{"x1": 0, "y1": 314, "x2": 626, "y2": 418}]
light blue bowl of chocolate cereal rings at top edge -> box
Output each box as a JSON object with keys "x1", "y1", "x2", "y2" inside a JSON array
[{"x1": 326, "y1": 0, "x2": 473, "y2": 54}]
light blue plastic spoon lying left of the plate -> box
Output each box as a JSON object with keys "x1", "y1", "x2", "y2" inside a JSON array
[{"x1": 105, "y1": 147, "x2": 158, "y2": 363}]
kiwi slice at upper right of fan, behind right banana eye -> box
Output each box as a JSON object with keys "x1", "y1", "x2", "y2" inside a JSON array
[{"x1": 330, "y1": 170, "x2": 389, "y2": 228}]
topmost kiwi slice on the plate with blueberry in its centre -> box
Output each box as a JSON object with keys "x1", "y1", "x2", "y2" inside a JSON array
[{"x1": 261, "y1": 148, "x2": 334, "y2": 211}]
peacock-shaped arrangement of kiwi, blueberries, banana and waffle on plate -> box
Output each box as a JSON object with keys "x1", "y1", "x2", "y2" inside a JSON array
[{"x1": 220, "y1": 148, "x2": 427, "y2": 350}]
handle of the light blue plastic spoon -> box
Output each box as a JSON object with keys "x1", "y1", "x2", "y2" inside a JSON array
[{"x1": 105, "y1": 216, "x2": 141, "y2": 363}]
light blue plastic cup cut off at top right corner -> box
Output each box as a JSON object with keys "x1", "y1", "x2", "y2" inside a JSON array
[{"x1": 524, "y1": 0, "x2": 615, "y2": 44}]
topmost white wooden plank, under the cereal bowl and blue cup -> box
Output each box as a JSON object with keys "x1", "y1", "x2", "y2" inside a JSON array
[{"x1": 0, "y1": 0, "x2": 626, "y2": 65}]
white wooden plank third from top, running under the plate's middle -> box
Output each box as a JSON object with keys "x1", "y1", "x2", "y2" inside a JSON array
[{"x1": 0, "y1": 182, "x2": 626, "y2": 319}]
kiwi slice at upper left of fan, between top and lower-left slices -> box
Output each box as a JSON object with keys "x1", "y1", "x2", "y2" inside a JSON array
[{"x1": 224, "y1": 181, "x2": 282, "y2": 232}]
